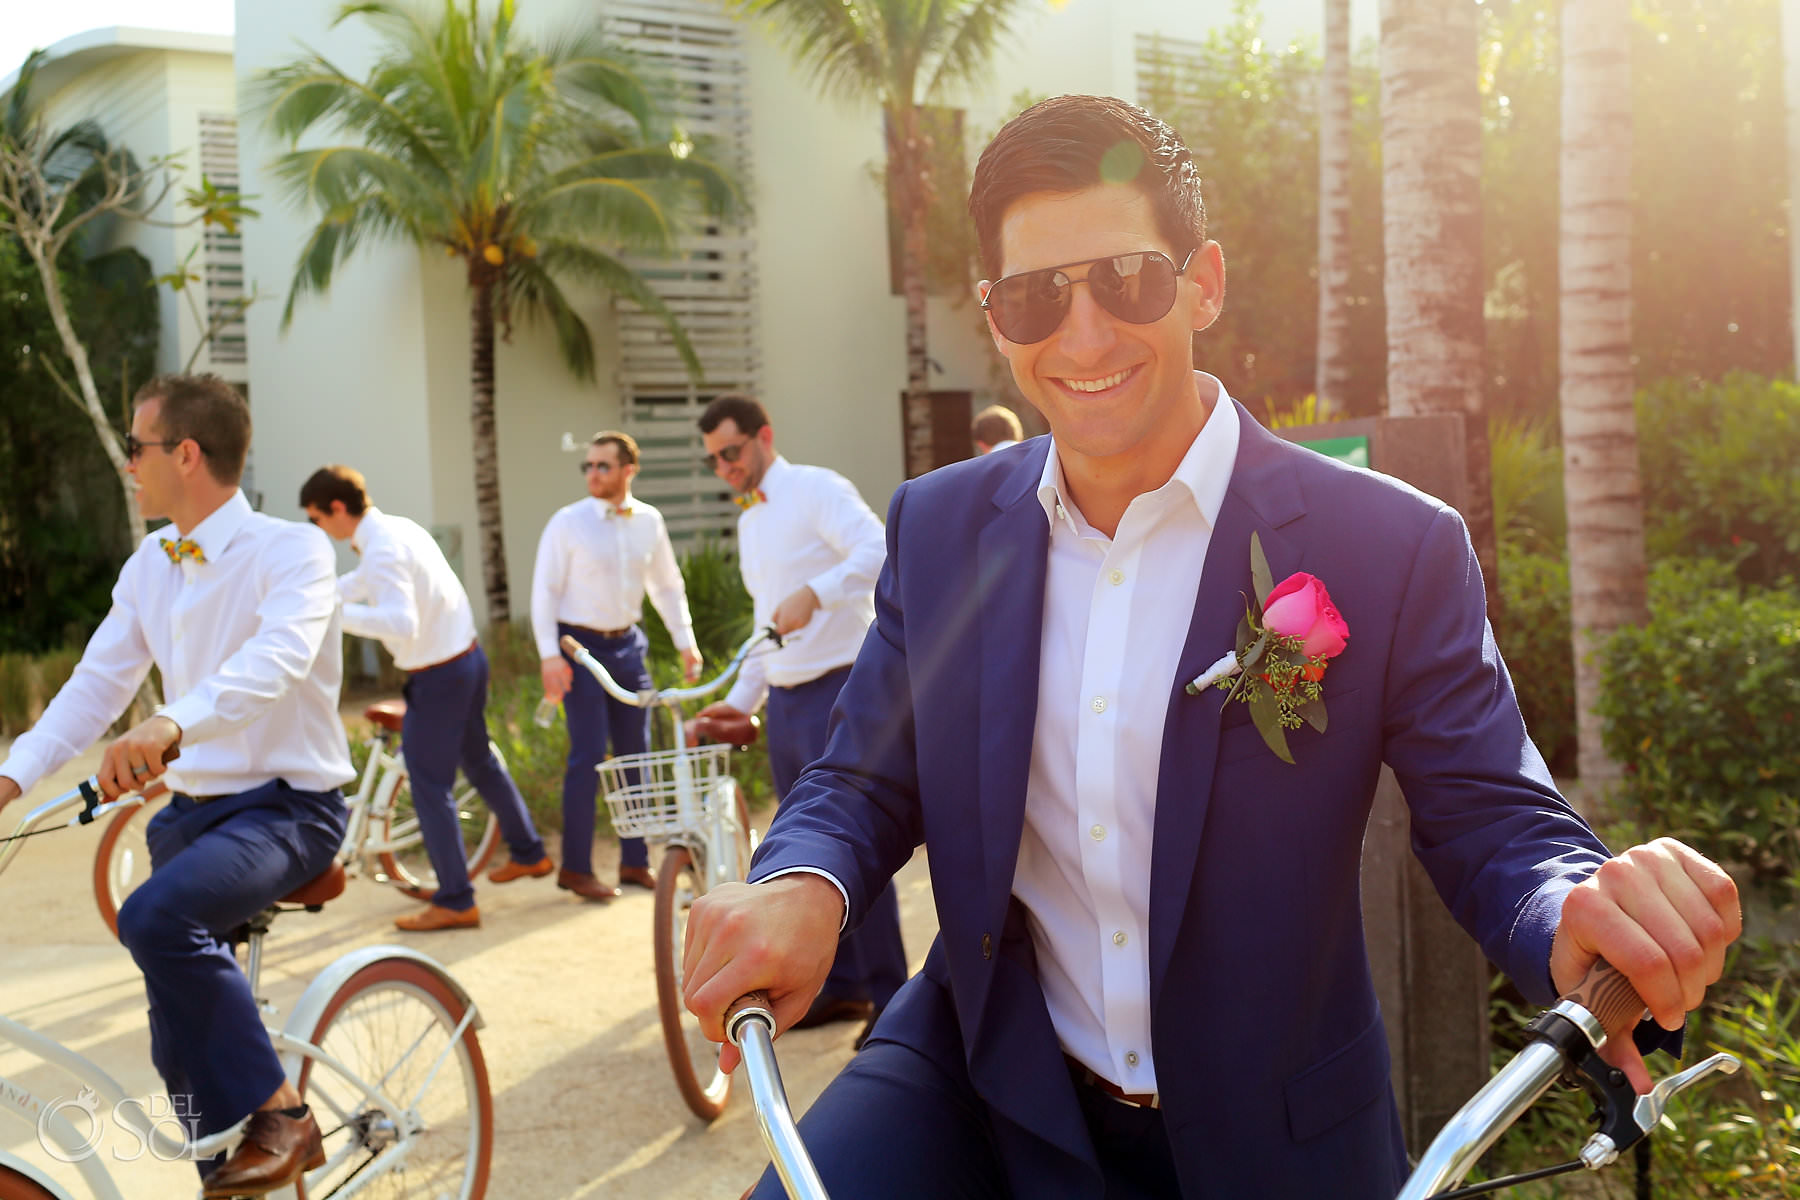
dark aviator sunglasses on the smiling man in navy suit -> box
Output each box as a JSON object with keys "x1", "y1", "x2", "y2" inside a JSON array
[{"x1": 981, "y1": 250, "x2": 1193, "y2": 345}]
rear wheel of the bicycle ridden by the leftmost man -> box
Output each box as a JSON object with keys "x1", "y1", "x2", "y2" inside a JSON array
[{"x1": 295, "y1": 959, "x2": 493, "y2": 1200}]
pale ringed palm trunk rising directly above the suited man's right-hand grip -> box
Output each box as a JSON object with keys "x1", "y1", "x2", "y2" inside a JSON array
[{"x1": 1561, "y1": 0, "x2": 1647, "y2": 795}]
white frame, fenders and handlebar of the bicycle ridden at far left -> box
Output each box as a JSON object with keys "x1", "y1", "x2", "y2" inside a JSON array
[{"x1": 0, "y1": 781, "x2": 482, "y2": 1200}]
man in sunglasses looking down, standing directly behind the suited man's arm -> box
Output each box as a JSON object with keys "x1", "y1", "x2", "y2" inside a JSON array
[{"x1": 700, "y1": 394, "x2": 905, "y2": 1042}]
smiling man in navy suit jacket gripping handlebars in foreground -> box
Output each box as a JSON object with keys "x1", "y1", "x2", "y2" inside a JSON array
[{"x1": 686, "y1": 95, "x2": 1739, "y2": 1200}]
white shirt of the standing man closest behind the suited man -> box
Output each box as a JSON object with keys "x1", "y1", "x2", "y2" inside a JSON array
[{"x1": 725, "y1": 455, "x2": 887, "y2": 712}]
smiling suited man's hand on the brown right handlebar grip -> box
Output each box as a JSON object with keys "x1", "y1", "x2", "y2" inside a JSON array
[{"x1": 1550, "y1": 838, "x2": 1744, "y2": 1094}]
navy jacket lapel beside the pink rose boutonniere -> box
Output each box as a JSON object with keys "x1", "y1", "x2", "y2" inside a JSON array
[{"x1": 1150, "y1": 401, "x2": 1305, "y2": 1004}]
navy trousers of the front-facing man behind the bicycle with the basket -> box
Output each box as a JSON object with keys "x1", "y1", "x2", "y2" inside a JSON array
[{"x1": 556, "y1": 624, "x2": 650, "y2": 874}]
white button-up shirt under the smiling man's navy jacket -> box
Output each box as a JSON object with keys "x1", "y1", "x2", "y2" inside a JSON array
[{"x1": 1013, "y1": 374, "x2": 1238, "y2": 1094}]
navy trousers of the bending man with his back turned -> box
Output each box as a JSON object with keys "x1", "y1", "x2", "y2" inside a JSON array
[{"x1": 400, "y1": 646, "x2": 544, "y2": 912}]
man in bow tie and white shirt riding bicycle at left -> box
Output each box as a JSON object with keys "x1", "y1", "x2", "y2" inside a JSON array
[{"x1": 0, "y1": 374, "x2": 353, "y2": 1196}]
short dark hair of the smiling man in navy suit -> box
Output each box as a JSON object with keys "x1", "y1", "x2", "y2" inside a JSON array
[{"x1": 968, "y1": 95, "x2": 1206, "y2": 279}]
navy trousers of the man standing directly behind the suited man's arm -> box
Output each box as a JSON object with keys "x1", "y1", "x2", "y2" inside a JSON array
[{"x1": 769, "y1": 667, "x2": 905, "y2": 1011}]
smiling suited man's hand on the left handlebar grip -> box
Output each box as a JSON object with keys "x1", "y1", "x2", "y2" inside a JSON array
[{"x1": 682, "y1": 873, "x2": 844, "y2": 1070}]
